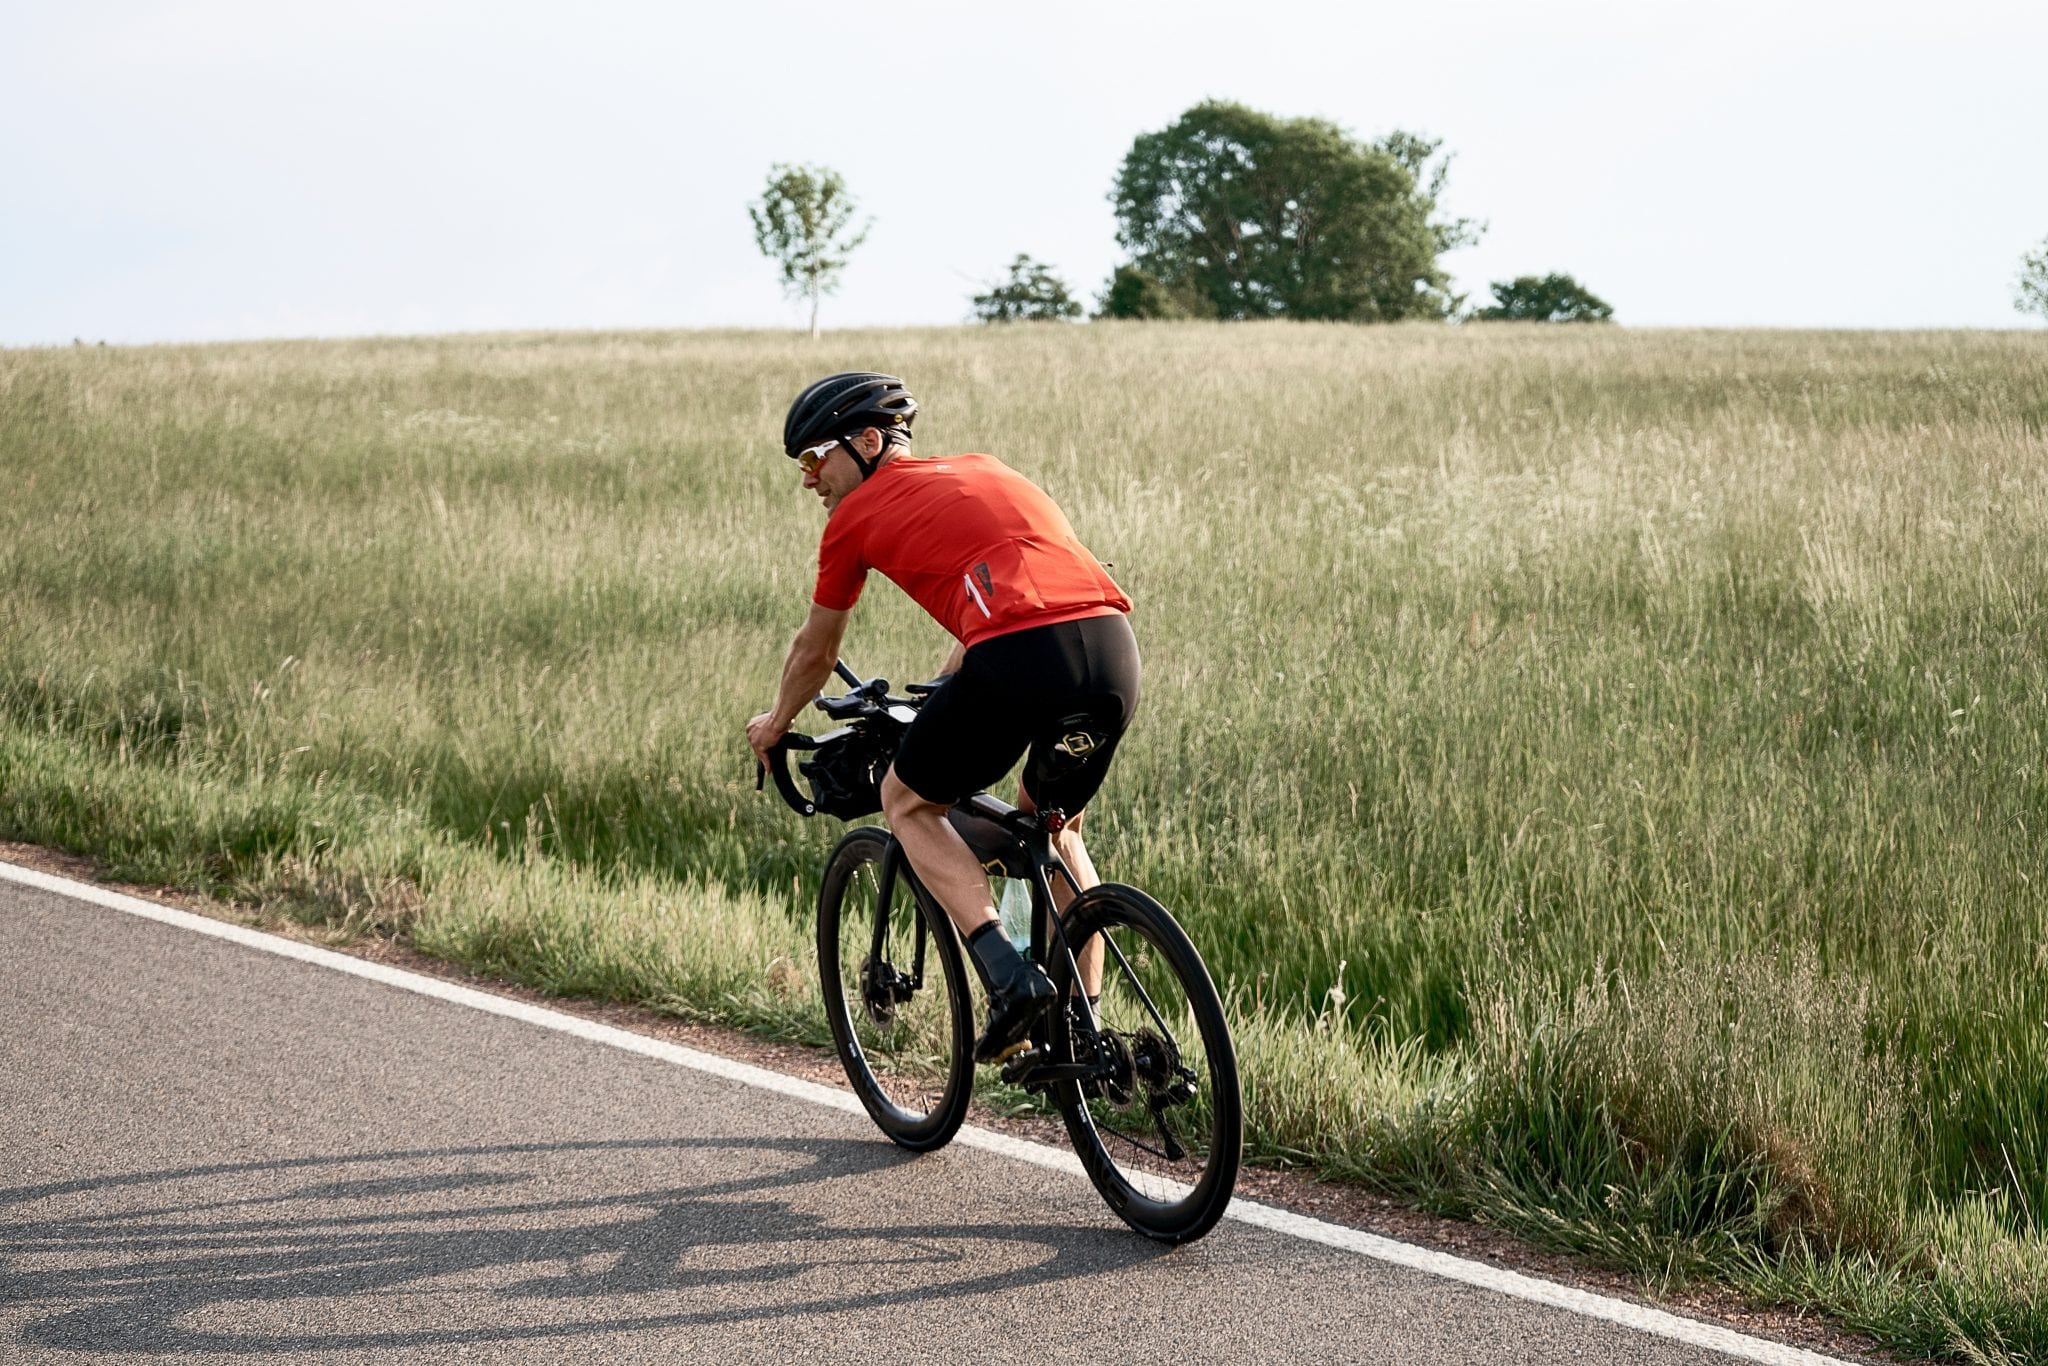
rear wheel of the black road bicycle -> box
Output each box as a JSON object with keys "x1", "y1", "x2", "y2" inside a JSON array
[{"x1": 1049, "y1": 883, "x2": 1243, "y2": 1243}]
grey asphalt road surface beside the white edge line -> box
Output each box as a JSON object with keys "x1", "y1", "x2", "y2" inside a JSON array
[{"x1": 0, "y1": 883, "x2": 1826, "y2": 1366}]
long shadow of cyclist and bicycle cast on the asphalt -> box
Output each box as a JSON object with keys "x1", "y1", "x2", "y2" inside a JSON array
[{"x1": 0, "y1": 1139, "x2": 1163, "y2": 1354}]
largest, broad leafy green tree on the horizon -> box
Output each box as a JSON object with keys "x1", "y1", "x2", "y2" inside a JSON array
[{"x1": 1110, "y1": 100, "x2": 1479, "y2": 322}]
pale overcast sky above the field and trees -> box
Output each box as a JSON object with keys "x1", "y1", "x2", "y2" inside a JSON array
[{"x1": 0, "y1": 0, "x2": 2048, "y2": 344}]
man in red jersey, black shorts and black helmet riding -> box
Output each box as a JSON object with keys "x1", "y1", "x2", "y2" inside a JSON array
[{"x1": 748, "y1": 371, "x2": 1139, "y2": 1063}]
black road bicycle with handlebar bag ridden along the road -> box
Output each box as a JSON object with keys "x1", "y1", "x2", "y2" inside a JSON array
[{"x1": 756, "y1": 661, "x2": 1243, "y2": 1243}]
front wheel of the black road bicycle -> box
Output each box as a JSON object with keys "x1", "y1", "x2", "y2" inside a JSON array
[{"x1": 817, "y1": 825, "x2": 975, "y2": 1153}]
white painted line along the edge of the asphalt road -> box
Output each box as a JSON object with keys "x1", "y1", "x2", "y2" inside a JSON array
[{"x1": 0, "y1": 862, "x2": 1847, "y2": 1366}]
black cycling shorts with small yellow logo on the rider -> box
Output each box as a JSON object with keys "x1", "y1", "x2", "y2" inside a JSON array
[{"x1": 895, "y1": 612, "x2": 1139, "y2": 817}]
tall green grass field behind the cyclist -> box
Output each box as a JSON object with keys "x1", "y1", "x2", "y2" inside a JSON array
[{"x1": 12, "y1": 324, "x2": 2048, "y2": 1360}]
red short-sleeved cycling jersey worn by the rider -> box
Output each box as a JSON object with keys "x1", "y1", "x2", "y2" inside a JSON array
[{"x1": 811, "y1": 455, "x2": 1130, "y2": 645}]
